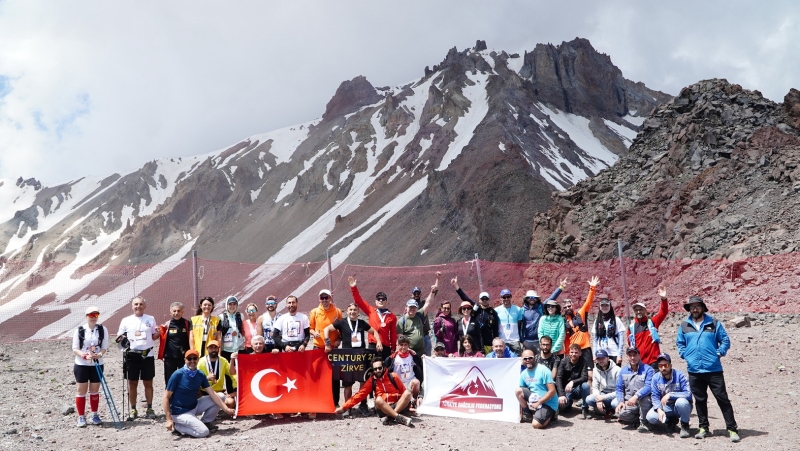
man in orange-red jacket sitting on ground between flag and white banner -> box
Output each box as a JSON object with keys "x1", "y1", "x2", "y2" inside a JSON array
[{"x1": 334, "y1": 357, "x2": 414, "y2": 427}]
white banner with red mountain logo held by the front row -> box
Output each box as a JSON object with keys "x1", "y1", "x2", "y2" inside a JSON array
[{"x1": 417, "y1": 357, "x2": 521, "y2": 423}]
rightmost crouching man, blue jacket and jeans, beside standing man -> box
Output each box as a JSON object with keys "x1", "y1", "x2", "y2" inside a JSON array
[{"x1": 647, "y1": 353, "x2": 692, "y2": 438}]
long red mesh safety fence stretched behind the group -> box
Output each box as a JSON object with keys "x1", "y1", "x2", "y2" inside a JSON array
[{"x1": 0, "y1": 253, "x2": 800, "y2": 341}]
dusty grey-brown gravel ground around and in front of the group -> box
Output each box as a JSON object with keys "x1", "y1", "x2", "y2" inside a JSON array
[{"x1": 0, "y1": 315, "x2": 800, "y2": 451}]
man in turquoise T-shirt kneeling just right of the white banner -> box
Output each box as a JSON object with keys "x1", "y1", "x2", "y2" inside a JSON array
[{"x1": 516, "y1": 349, "x2": 558, "y2": 429}]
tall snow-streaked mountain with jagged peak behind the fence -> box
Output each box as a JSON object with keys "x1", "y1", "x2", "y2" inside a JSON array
[{"x1": 0, "y1": 39, "x2": 670, "y2": 334}]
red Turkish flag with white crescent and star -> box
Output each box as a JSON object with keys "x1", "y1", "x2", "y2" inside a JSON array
[{"x1": 236, "y1": 349, "x2": 336, "y2": 416}]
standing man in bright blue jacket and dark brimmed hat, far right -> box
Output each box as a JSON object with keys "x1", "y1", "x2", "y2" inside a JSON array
[{"x1": 675, "y1": 296, "x2": 739, "y2": 442}]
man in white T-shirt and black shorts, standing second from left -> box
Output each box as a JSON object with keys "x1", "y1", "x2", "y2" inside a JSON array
[{"x1": 117, "y1": 296, "x2": 160, "y2": 420}]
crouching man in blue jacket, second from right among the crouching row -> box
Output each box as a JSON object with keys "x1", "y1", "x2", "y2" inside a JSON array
[{"x1": 616, "y1": 348, "x2": 654, "y2": 432}]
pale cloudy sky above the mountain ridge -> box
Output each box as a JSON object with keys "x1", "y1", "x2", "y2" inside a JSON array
[{"x1": 0, "y1": 0, "x2": 800, "y2": 185}]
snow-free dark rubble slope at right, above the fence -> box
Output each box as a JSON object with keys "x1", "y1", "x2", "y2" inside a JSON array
[{"x1": 530, "y1": 79, "x2": 800, "y2": 262}]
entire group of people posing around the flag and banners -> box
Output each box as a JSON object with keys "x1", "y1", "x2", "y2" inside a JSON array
[{"x1": 73, "y1": 273, "x2": 739, "y2": 441}]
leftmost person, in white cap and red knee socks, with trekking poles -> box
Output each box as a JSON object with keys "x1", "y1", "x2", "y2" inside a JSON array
[{"x1": 72, "y1": 306, "x2": 108, "y2": 427}]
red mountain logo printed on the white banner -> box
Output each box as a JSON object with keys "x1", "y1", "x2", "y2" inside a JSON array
[{"x1": 439, "y1": 366, "x2": 503, "y2": 413}]
